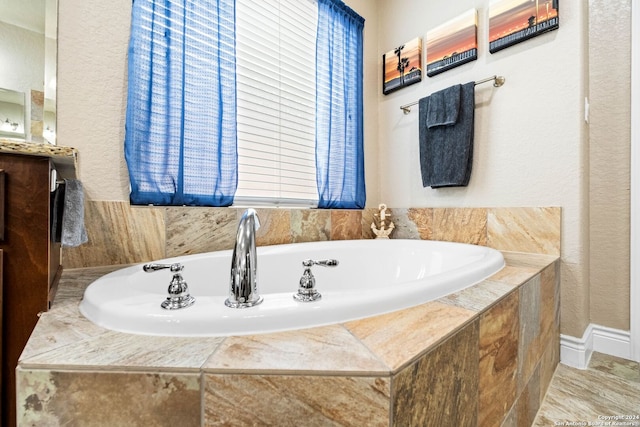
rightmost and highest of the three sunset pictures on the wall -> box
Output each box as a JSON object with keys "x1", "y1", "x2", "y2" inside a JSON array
[{"x1": 489, "y1": 0, "x2": 560, "y2": 53}]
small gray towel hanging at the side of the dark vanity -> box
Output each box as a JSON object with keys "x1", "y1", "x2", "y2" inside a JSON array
[{"x1": 60, "y1": 179, "x2": 89, "y2": 247}]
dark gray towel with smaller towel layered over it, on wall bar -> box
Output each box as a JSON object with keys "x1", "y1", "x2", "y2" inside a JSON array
[{"x1": 418, "y1": 82, "x2": 475, "y2": 188}]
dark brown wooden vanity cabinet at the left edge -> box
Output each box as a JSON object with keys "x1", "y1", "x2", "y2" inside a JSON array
[{"x1": 0, "y1": 153, "x2": 62, "y2": 427}]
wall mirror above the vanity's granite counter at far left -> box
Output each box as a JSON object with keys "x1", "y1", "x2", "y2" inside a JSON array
[{"x1": 0, "y1": 0, "x2": 58, "y2": 144}]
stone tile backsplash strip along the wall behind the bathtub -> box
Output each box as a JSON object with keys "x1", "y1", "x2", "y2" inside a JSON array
[{"x1": 62, "y1": 201, "x2": 561, "y2": 268}]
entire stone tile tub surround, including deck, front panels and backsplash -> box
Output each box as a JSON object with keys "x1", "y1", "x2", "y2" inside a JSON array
[{"x1": 18, "y1": 201, "x2": 561, "y2": 426}]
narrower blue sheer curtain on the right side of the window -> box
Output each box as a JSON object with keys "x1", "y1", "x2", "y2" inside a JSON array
[{"x1": 316, "y1": 0, "x2": 366, "y2": 208}]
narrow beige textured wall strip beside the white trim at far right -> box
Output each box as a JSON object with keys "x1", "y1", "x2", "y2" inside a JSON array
[{"x1": 589, "y1": 0, "x2": 631, "y2": 330}]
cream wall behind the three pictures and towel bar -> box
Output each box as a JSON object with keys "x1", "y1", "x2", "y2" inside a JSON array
[{"x1": 378, "y1": 0, "x2": 590, "y2": 342}]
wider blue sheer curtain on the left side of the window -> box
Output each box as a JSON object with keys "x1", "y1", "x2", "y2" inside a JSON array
[{"x1": 125, "y1": 0, "x2": 237, "y2": 206}]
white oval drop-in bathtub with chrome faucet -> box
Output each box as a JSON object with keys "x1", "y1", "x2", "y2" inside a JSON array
[{"x1": 80, "y1": 240, "x2": 504, "y2": 336}]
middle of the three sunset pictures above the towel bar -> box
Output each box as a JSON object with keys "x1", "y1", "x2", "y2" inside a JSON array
[{"x1": 426, "y1": 9, "x2": 478, "y2": 77}]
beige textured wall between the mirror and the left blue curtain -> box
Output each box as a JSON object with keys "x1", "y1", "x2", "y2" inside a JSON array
[{"x1": 57, "y1": 0, "x2": 131, "y2": 200}]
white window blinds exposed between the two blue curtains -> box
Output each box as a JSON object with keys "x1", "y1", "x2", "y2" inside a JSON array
[{"x1": 234, "y1": 0, "x2": 318, "y2": 206}]
